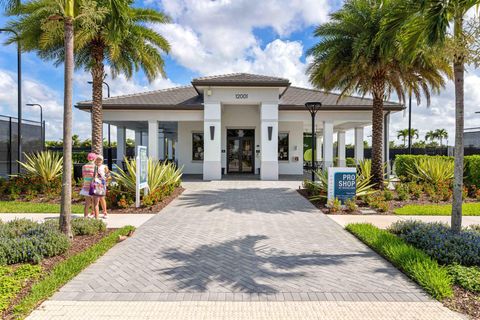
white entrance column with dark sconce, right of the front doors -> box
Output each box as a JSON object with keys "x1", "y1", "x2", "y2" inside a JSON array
[{"x1": 260, "y1": 103, "x2": 278, "y2": 180}]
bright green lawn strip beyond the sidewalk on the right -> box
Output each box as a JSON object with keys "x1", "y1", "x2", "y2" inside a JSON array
[{"x1": 394, "y1": 202, "x2": 480, "y2": 216}]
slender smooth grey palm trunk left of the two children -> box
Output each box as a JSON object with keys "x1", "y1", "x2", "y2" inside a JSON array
[{"x1": 60, "y1": 15, "x2": 73, "y2": 239}]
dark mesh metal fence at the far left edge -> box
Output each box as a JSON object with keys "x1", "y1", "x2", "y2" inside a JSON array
[{"x1": 0, "y1": 115, "x2": 45, "y2": 177}]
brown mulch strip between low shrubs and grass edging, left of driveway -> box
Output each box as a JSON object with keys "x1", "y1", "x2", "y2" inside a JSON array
[{"x1": 0, "y1": 229, "x2": 116, "y2": 320}]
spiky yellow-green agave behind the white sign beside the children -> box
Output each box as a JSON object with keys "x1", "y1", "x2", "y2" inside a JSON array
[{"x1": 112, "y1": 158, "x2": 182, "y2": 192}]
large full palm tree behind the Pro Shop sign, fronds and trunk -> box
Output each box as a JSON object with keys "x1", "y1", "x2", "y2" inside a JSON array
[{"x1": 308, "y1": 0, "x2": 445, "y2": 188}]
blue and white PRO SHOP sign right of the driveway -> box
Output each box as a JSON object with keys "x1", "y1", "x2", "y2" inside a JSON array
[{"x1": 328, "y1": 167, "x2": 357, "y2": 204}]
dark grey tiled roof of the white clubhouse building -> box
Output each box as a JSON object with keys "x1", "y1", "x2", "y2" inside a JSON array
[{"x1": 76, "y1": 73, "x2": 405, "y2": 111}]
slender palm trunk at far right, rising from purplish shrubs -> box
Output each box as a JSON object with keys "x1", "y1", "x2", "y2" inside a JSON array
[{"x1": 451, "y1": 16, "x2": 465, "y2": 232}]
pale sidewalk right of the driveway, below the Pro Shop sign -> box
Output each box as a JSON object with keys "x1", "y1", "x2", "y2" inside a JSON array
[{"x1": 327, "y1": 214, "x2": 480, "y2": 229}]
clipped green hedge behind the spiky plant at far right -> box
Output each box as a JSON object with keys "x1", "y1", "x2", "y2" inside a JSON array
[{"x1": 395, "y1": 154, "x2": 480, "y2": 186}]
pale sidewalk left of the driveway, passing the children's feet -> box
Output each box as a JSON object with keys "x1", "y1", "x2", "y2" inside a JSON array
[{"x1": 0, "y1": 213, "x2": 155, "y2": 228}]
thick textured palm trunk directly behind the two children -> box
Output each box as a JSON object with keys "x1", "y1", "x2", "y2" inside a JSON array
[{"x1": 91, "y1": 45, "x2": 104, "y2": 154}]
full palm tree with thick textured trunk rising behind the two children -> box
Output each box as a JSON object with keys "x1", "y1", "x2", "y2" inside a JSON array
[{"x1": 11, "y1": 0, "x2": 170, "y2": 153}]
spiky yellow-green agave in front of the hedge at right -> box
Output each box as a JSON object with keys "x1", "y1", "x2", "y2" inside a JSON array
[{"x1": 407, "y1": 157, "x2": 454, "y2": 185}]
